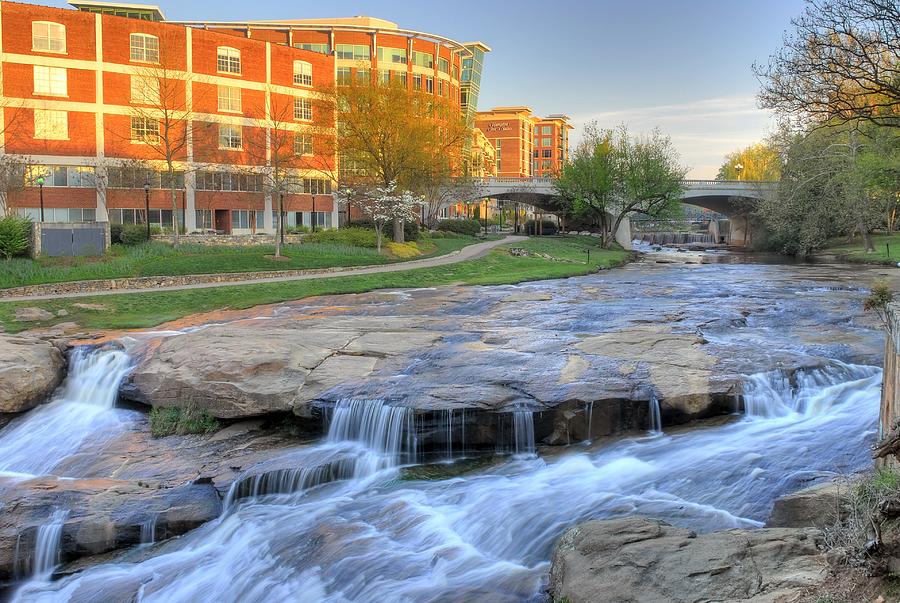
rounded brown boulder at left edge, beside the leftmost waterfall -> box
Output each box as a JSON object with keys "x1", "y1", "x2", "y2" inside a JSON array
[{"x1": 0, "y1": 335, "x2": 66, "y2": 415}]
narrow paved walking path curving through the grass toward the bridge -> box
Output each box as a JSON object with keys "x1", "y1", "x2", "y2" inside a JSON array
[{"x1": 0, "y1": 235, "x2": 527, "y2": 303}]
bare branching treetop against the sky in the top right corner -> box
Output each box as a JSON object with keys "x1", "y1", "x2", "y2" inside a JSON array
[{"x1": 754, "y1": 0, "x2": 900, "y2": 128}]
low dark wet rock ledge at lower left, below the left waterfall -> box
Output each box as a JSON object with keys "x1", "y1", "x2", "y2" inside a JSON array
[{"x1": 0, "y1": 420, "x2": 305, "y2": 590}]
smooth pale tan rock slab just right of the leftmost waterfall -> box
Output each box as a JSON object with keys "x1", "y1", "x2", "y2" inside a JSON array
[{"x1": 122, "y1": 319, "x2": 439, "y2": 419}]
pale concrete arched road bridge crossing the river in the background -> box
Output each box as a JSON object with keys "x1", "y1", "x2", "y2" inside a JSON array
[{"x1": 458, "y1": 178, "x2": 777, "y2": 246}]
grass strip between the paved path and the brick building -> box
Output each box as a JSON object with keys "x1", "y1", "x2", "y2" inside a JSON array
[{"x1": 0, "y1": 237, "x2": 478, "y2": 289}]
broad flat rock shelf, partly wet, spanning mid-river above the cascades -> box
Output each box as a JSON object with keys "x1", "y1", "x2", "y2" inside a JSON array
[{"x1": 123, "y1": 264, "x2": 882, "y2": 445}]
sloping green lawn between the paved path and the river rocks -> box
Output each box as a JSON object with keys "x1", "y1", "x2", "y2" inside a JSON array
[{"x1": 0, "y1": 236, "x2": 631, "y2": 332}]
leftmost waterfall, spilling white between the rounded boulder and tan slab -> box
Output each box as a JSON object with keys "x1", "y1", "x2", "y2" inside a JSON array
[{"x1": 0, "y1": 348, "x2": 131, "y2": 475}]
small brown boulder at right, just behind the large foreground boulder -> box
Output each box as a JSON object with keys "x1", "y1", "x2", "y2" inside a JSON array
[{"x1": 766, "y1": 482, "x2": 850, "y2": 528}]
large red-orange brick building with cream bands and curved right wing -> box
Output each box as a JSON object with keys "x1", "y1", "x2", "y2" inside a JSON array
[{"x1": 0, "y1": 1, "x2": 490, "y2": 234}]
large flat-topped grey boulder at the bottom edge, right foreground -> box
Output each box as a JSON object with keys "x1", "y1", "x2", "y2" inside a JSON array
[{"x1": 550, "y1": 517, "x2": 826, "y2": 603}]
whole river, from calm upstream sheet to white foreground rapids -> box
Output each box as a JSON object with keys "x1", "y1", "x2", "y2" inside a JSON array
[{"x1": 0, "y1": 249, "x2": 881, "y2": 602}]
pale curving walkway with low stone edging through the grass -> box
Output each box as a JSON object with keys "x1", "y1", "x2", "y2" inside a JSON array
[{"x1": 0, "y1": 236, "x2": 527, "y2": 303}]
